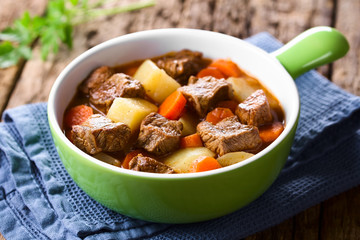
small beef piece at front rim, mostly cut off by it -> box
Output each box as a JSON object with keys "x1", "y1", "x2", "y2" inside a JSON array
[{"x1": 129, "y1": 154, "x2": 175, "y2": 173}]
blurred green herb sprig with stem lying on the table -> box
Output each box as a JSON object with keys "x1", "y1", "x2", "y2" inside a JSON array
[{"x1": 0, "y1": 0, "x2": 155, "y2": 68}]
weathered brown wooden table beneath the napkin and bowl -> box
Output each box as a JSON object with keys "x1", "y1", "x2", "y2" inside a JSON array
[{"x1": 0, "y1": 0, "x2": 360, "y2": 240}]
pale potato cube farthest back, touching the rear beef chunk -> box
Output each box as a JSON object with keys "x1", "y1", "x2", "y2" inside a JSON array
[{"x1": 134, "y1": 59, "x2": 180, "y2": 103}]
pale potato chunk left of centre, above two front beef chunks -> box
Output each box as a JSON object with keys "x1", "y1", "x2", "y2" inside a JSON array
[{"x1": 107, "y1": 97, "x2": 158, "y2": 131}]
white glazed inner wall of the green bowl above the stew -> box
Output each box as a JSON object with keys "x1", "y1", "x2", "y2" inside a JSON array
[{"x1": 48, "y1": 29, "x2": 299, "y2": 176}]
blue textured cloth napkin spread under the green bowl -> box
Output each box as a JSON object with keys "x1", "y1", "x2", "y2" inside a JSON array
[{"x1": 0, "y1": 33, "x2": 360, "y2": 239}]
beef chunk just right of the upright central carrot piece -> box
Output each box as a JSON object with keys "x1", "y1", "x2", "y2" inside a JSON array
[{"x1": 178, "y1": 76, "x2": 232, "y2": 117}]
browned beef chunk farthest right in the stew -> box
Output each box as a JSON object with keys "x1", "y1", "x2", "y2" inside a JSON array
[{"x1": 235, "y1": 89, "x2": 272, "y2": 126}]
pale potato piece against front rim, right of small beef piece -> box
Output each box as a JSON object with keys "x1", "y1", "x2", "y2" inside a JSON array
[{"x1": 164, "y1": 147, "x2": 215, "y2": 173}]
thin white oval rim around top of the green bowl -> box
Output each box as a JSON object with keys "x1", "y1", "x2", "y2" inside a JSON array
[{"x1": 47, "y1": 28, "x2": 300, "y2": 180}]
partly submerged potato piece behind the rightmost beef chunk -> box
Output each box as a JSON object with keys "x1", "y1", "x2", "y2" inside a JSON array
[{"x1": 227, "y1": 76, "x2": 281, "y2": 110}]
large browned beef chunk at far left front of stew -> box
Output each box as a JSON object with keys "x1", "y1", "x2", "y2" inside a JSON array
[{"x1": 71, "y1": 114, "x2": 131, "y2": 154}]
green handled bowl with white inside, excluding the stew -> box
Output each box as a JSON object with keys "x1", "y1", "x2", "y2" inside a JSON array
[{"x1": 48, "y1": 27, "x2": 348, "y2": 223}]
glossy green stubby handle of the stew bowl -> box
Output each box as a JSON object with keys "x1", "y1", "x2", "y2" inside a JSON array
[{"x1": 271, "y1": 27, "x2": 349, "y2": 79}]
